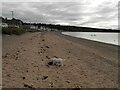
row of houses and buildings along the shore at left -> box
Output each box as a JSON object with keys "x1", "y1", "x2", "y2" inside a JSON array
[{"x1": 0, "y1": 17, "x2": 56, "y2": 31}]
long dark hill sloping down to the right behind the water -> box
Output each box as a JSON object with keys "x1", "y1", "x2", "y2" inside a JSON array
[{"x1": 24, "y1": 23, "x2": 120, "y2": 32}]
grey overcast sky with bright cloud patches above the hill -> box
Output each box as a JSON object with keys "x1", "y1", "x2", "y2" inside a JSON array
[{"x1": 2, "y1": 0, "x2": 119, "y2": 29}]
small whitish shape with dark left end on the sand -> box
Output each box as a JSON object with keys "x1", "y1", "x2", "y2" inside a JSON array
[{"x1": 48, "y1": 57, "x2": 64, "y2": 66}]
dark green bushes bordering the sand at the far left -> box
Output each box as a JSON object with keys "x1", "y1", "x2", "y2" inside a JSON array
[{"x1": 2, "y1": 28, "x2": 26, "y2": 35}]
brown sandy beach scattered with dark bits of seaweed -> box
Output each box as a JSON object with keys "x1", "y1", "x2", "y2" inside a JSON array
[{"x1": 2, "y1": 32, "x2": 120, "y2": 88}]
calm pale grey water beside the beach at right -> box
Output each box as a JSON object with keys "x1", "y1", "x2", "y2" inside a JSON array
[{"x1": 62, "y1": 32, "x2": 120, "y2": 45}]
